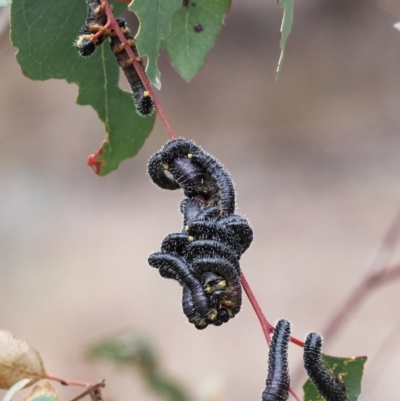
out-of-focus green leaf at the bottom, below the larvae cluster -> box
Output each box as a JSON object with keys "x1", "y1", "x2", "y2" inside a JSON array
[{"x1": 88, "y1": 332, "x2": 190, "y2": 401}]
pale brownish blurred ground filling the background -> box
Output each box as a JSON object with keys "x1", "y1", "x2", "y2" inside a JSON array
[{"x1": 0, "y1": 0, "x2": 400, "y2": 401}]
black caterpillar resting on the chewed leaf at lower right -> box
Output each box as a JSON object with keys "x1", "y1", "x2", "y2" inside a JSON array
[{"x1": 303, "y1": 333, "x2": 347, "y2": 401}]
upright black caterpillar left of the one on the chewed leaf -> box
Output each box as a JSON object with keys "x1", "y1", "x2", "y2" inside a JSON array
[{"x1": 262, "y1": 319, "x2": 290, "y2": 401}]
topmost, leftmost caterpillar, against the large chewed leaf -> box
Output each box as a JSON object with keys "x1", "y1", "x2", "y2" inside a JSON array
[{"x1": 75, "y1": 0, "x2": 109, "y2": 57}]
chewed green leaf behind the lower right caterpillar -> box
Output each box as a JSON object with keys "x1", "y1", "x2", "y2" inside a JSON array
[{"x1": 303, "y1": 354, "x2": 367, "y2": 401}]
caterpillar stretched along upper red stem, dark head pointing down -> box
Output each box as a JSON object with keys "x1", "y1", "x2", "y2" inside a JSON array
[{"x1": 110, "y1": 18, "x2": 154, "y2": 116}]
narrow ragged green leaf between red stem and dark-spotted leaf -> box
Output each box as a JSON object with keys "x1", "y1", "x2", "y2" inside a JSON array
[{"x1": 128, "y1": 0, "x2": 182, "y2": 89}]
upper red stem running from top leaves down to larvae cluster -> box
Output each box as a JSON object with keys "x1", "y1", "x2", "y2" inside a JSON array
[{"x1": 100, "y1": 0, "x2": 176, "y2": 139}]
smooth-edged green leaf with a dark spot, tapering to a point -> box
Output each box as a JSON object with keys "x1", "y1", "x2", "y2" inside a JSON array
[{"x1": 161, "y1": 0, "x2": 231, "y2": 81}]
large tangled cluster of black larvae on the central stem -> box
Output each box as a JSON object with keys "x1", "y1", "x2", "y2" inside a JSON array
[{"x1": 148, "y1": 139, "x2": 253, "y2": 329}]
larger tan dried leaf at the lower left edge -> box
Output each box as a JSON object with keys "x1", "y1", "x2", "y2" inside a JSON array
[{"x1": 0, "y1": 330, "x2": 45, "y2": 389}]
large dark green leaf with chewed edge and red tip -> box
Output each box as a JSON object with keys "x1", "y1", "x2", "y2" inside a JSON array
[{"x1": 11, "y1": 0, "x2": 155, "y2": 176}]
